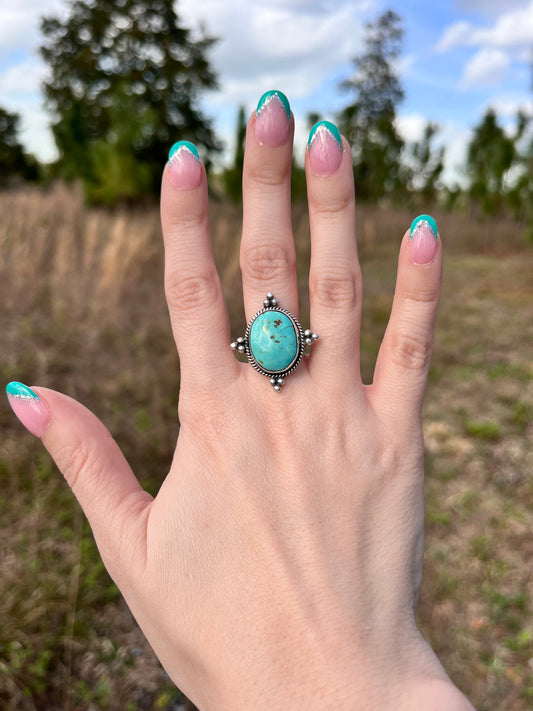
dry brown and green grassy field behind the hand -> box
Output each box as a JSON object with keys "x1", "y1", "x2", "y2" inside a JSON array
[{"x1": 0, "y1": 186, "x2": 533, "y2": 711}]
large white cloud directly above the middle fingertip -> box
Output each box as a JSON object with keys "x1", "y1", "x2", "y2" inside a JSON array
[{"x1": 178, "y1": 0, "x2": 370, "y2": 106}]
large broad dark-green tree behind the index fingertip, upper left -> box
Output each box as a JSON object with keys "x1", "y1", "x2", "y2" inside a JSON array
[{"x1": 41, "y1": 0, "x2": 220, "y2": 202}]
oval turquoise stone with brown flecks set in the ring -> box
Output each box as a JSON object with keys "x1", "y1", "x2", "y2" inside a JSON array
[{"x1": 249, "y1": 311, "x2": 298, "y2": 373}]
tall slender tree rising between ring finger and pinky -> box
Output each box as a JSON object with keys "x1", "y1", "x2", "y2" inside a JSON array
[{"x1": 339, "y1": 10, "x2": 404, "y2": 200}]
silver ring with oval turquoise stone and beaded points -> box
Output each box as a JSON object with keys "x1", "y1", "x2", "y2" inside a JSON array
[{"x1": 231, "y1": 291, "x2": 318, "y2": 391}]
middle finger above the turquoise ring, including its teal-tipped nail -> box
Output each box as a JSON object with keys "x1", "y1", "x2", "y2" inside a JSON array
[{"x1": 240, "y1": 91, "x2": 298, "y2": 320}]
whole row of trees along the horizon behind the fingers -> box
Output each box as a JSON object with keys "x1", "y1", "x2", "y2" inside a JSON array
[{"x1": 0, "y1": 0, "x2": 533, "y2": 225}]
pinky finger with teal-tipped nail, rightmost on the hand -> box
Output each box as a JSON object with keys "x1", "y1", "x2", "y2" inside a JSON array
[{"x1": 370, "y1": 215, "x2": 442, "y2": 426}]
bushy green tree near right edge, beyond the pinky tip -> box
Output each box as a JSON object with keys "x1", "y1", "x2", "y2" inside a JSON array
[{"x1": 466, "y1": 108, "x2": 516, "y2": 215}]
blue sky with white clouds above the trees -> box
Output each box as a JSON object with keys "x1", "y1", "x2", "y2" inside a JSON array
[{"x1": 0, "y1": 0, "x2": 533, "y2": 183}]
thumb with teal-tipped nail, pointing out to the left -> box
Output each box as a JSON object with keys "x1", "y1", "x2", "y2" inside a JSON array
[{"x1": 6, "y1": 382, "x2": 152, "y2": 577}]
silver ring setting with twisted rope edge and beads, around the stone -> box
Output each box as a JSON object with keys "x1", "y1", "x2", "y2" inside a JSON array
[{"x1": 231, "y1": 292, "x2": 318, "y2": 391}]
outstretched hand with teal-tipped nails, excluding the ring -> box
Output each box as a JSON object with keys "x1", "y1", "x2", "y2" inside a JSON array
[{"x1": 6, "y1": 95, "x2": 472, "y2": 711}]
